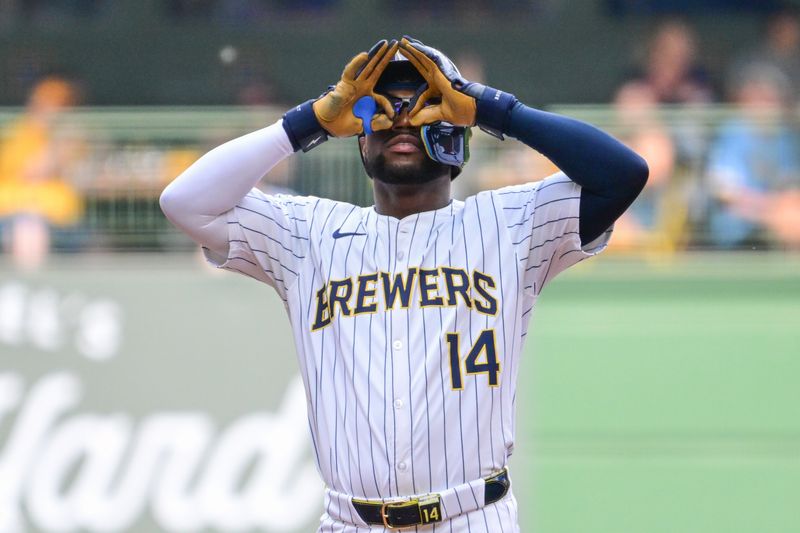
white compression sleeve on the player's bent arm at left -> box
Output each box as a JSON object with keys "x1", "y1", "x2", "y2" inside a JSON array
[{"x1": 160, "y1": 120, "x2": 294, "y2": 257}]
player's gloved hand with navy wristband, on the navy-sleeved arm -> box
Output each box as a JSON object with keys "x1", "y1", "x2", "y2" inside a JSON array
[{"x1": 400, "y1": 35, "x2": 517, "y2": 139}]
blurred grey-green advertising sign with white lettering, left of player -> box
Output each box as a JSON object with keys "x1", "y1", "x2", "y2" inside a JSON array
[{"x1": 0, "y1": 255, "x2": 322, "y2": 532}]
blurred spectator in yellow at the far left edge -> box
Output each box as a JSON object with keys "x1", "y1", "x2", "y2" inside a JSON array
[{"x1": 0, "y1": 77, "x2": 82, "y2": 267}]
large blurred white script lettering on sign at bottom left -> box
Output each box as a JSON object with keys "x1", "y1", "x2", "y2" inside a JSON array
[{"x1": 0, "y1": 372, "x2": 322, "y2": 532}]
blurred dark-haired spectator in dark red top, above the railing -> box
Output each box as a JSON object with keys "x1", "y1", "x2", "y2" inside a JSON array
[{"x1": 620, "y1": 20, "x2": 714, "y2": 104}]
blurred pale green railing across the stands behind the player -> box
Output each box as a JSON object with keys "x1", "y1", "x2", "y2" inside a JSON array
[{"x1": 0, "y1": 106, "x2": 800, "y2": 252}]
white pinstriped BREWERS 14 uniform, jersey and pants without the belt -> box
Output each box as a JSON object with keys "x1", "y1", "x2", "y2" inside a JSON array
[{"x1": 206, "y1": 173, "x2": 610, "y2": 532}]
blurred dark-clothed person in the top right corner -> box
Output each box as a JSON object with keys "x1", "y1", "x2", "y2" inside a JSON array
[{"x1": 729, "y1": 10, "x2": 800, "y2": 101}]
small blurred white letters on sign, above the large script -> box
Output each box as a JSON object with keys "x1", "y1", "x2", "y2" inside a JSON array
[{"x1": 0, "y1": 281, "x2": 122, "y2": 361}]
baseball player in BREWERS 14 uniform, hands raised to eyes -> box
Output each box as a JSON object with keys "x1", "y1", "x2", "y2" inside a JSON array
[{"x1": 161, "y1": 37, "x2": 648, "y2": 533}]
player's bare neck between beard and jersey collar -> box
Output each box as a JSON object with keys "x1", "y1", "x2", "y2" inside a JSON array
[{"x1": 373, "y1": 175, "x2": 450, "y2": 219}]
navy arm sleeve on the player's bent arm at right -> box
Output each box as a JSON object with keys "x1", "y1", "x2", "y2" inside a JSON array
[{"x1": 504, "y1": 103, "x2": 649, "y2": 244}]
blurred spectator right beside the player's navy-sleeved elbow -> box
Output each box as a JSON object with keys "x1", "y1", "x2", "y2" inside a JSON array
[{"x1": 614, "y1": 83, "x2": 689, "y2": 252}]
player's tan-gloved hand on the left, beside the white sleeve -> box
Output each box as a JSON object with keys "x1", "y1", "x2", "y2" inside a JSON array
[{"x1": 313, "y1": 39, "x2": 399, "y2": 137}]
